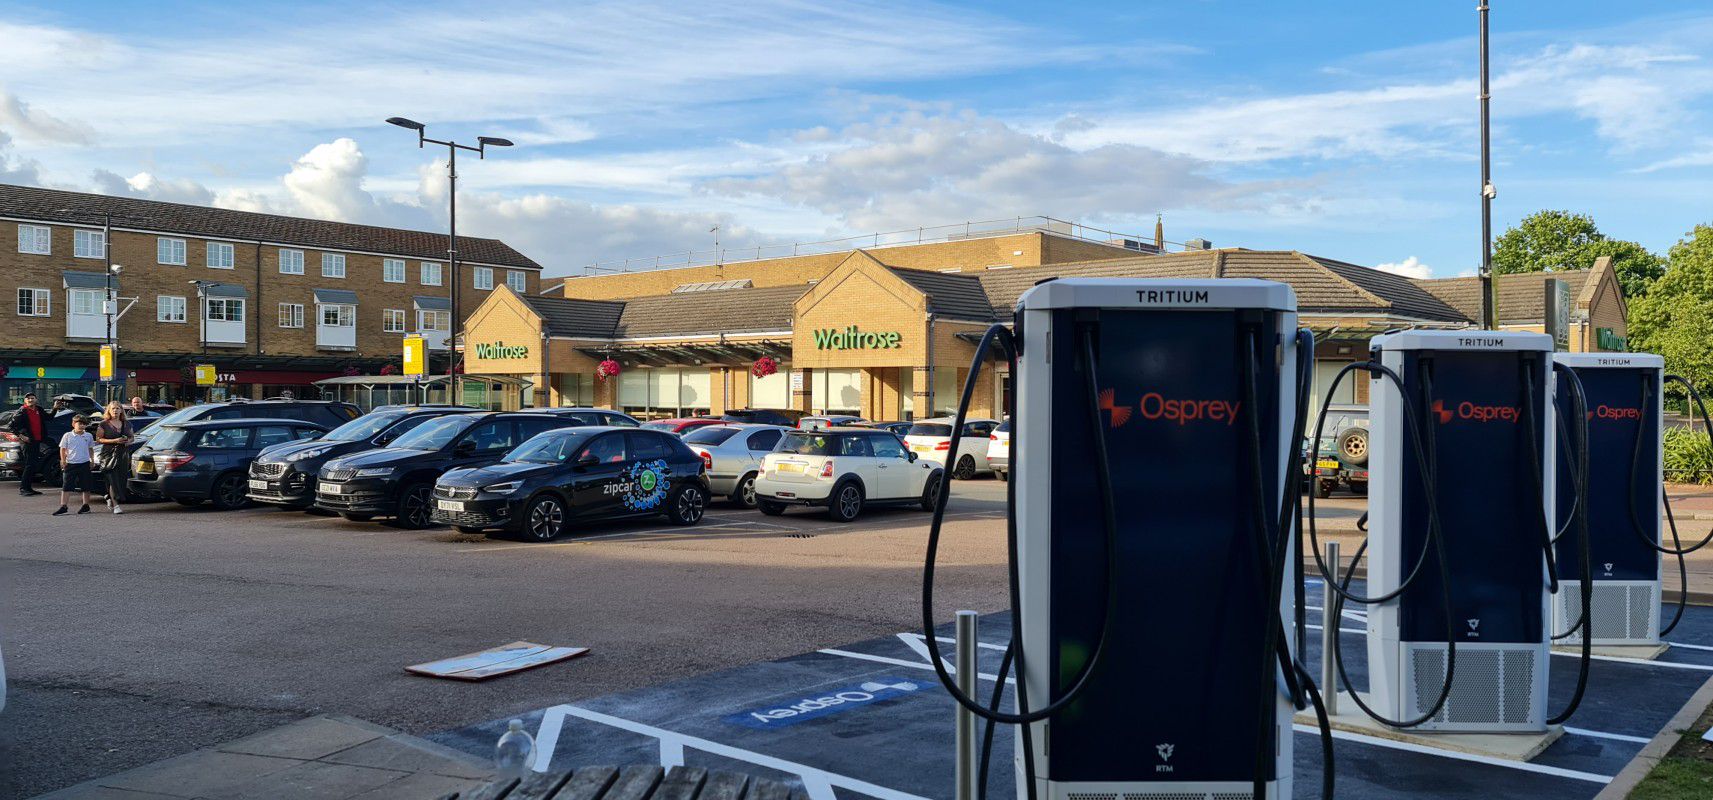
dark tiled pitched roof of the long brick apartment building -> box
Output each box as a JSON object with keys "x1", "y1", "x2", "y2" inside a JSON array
[{"x1": 0, "y1": 183, "x2": 541, "y2": 269}]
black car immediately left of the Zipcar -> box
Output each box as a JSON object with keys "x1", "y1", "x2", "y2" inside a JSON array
[{"x1": 315, "y1": 411, "x2": 577, "y2": 528}]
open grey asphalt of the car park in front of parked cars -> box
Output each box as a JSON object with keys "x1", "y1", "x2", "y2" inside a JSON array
[{"x1": 0, "y1": 478, "x2": 1004, "y2": 798}]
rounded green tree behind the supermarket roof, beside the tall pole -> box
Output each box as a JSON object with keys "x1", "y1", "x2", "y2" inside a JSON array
[{"x1": 1494, "y1": 211, "x2": 1665, "y2": 298}]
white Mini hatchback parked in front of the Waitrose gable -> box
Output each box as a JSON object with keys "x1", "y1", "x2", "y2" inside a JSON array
[{"x1": 755, "y1": 428, "x2": 946, "y2": 522}]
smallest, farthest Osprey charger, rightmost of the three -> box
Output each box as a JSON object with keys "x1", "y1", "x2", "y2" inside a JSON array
[{"x1": 1552, "y1": 353, "x2": 1665, "y2": 646}]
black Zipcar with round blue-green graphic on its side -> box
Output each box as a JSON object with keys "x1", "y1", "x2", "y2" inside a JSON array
[{"x1": 433, "y1": 428, "x2": 709, "y2": 541}]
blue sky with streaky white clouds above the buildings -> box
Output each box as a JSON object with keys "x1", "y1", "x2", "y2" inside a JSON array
[{"x1": 0, "y1": 0, "x2": 1713, "y2": 276}]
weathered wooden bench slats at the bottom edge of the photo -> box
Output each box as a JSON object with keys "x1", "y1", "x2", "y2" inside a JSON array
[{"x1": 440, "y1": 764, "x2": 809, "y2": 800}]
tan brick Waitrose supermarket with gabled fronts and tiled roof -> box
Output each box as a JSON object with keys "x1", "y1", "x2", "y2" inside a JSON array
[{"x1": 464, "y1": 230, "x2": 1626, "y2": 420}]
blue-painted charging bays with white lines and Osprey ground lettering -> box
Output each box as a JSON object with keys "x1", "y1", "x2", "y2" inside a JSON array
[{"x1": 430, "y1": 602, "x2": 1713, "y2": 800}]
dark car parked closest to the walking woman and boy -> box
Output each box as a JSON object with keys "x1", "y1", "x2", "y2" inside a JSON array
[{"x1": 125, "y1": 418, "x2": 327, "y2": 509}]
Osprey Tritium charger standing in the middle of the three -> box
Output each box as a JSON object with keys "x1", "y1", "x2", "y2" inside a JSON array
[{"x1": 1367, "y1": 331, "x2": 1555, "y2": 733}]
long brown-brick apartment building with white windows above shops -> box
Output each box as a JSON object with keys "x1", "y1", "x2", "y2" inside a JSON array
[{"x1": 0, "y1": 185, "x2": 541, "y2": 403}]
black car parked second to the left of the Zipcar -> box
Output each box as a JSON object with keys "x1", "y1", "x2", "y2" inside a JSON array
[{"x1": 250, "y1": 406, "x2": 475, "y2": 509}]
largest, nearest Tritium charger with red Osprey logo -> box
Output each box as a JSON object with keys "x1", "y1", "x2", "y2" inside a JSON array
[{"x1": 1011, "y1": 279, "x2": 1301, "y2": 800}]
